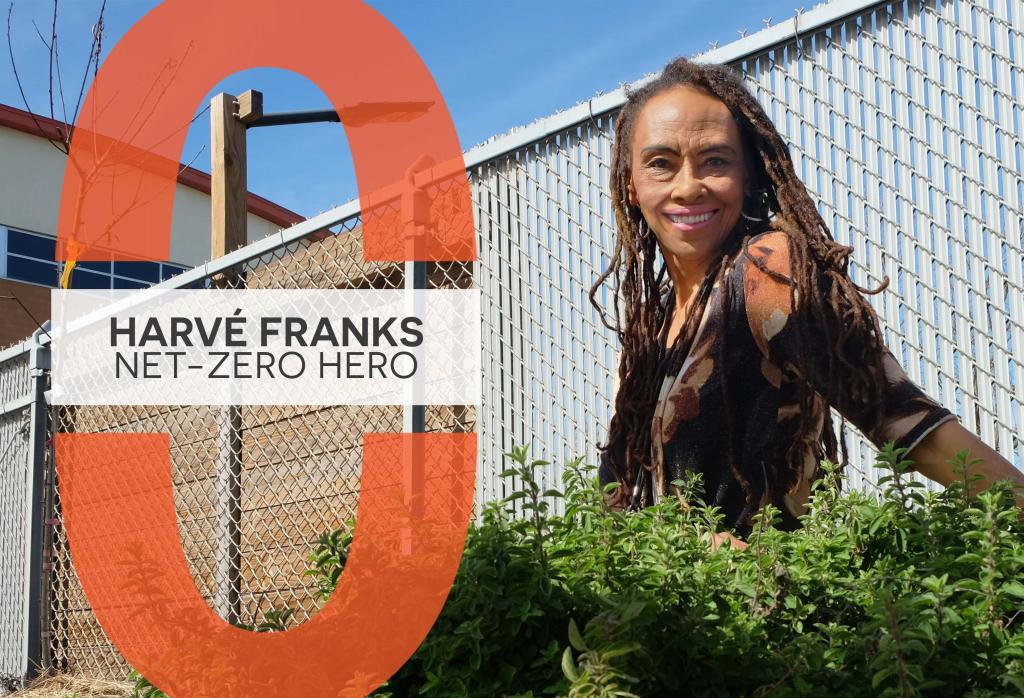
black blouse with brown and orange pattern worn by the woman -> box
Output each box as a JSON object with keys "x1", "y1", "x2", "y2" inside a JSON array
[{"x1": 614, "y1": 218, "x2": 954, "y2": 535}]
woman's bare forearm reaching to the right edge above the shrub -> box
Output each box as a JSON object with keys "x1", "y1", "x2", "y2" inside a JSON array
[{"x1": 906, "y1": 420, "x2": 1024, "y2": 507}]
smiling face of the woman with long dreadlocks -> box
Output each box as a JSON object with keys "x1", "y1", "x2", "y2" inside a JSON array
[{"x1": 629, "y1": 87, "x2": 746, "y2": 269}]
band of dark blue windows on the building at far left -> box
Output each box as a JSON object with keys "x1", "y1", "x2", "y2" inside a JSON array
[{"x1": 0, "y1": 226, "x2": 188, "y2": 289}]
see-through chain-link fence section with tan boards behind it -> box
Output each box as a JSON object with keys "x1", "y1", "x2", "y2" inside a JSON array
[{"x1": 50, "y1": 201, "x2": 475, "y2": 677}]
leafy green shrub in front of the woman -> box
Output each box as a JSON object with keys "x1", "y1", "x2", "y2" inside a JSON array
[{"x1": 130, "y1": 444, "x2": 1024, "y2": 698}]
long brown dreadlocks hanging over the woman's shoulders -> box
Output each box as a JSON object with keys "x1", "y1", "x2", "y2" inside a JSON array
[{"x1": 590, "y1": 57, "x2": 888, "y2": 507}]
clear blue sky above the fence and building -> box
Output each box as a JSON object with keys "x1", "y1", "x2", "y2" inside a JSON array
[{"x1": 0, "y1": 0, "x2": 813, "y2": 216}]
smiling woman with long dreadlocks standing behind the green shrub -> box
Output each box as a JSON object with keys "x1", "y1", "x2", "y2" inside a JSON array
[{"x1": 590, "y1": 58, "x2": 1024, "y2": 547}]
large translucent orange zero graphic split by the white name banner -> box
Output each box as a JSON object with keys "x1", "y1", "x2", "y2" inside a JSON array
[{"x1": 55, "y1": 0, "x2": 476, "y2": 698}]
